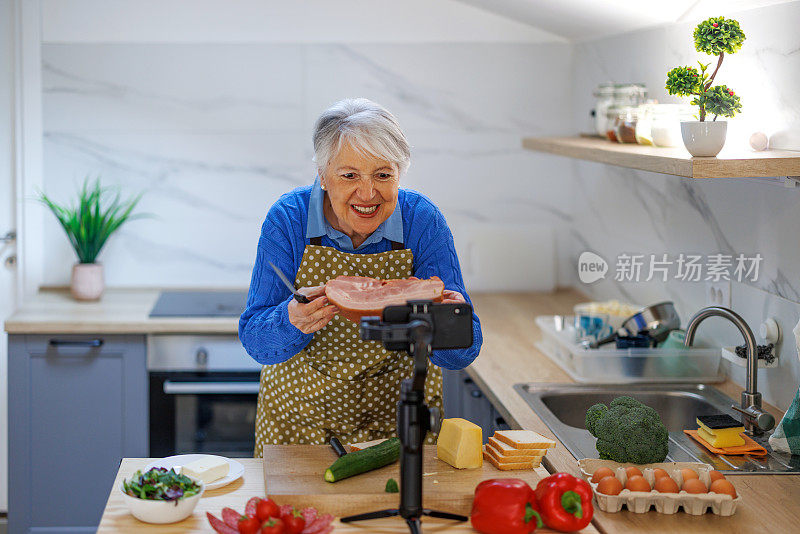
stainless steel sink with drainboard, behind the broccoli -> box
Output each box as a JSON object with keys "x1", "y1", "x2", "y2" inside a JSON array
[{"x1": 514, "y1": 383, "x2": 800, "y2": 475}]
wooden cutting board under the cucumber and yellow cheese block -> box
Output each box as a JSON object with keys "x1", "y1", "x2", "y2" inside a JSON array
[{"x1": 264, "y1": 445, "x2": 548, "y2": 517}]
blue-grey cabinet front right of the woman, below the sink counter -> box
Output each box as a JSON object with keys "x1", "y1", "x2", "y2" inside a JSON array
[{"x1": 442, "y1": 369, "x2": 509, "y2": 443}]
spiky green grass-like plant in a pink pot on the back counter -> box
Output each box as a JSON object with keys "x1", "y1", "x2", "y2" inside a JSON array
[{"x1": 39, "y1": 178, "x2": 142, "y2": 300}]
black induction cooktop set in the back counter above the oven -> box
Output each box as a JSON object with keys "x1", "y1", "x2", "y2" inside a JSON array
[{"x1": 150, "y1": 291, "x2": 247, "y2": 317}]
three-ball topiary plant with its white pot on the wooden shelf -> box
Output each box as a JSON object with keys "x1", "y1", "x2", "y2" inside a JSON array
[{"x1": 666, "y1": 17, "x2": 745, "y2": 156}]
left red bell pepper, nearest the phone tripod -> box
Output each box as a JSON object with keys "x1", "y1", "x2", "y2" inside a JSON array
[{"x1": 470, "y1": 478, "x2": 542, "y2": 534}]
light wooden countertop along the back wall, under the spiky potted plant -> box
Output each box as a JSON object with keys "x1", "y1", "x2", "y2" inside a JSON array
[{"x1": 5, "y1": 289, "x2": 239, "y2": 334}]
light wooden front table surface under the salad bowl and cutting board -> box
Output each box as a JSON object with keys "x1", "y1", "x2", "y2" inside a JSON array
[{"x1": 97, "y1": 458, "x2": 597, "y2": 534}]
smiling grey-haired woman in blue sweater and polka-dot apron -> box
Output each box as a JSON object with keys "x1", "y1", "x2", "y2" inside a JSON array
[{"x1": 239, "y1": 98, "x2": 482, "y2": 457}]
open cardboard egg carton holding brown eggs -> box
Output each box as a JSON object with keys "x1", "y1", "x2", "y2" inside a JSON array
[{"x1": 578, "y1": 458, "x2": 742, "y2": 516}]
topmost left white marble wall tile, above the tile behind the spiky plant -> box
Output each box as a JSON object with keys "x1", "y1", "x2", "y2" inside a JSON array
[{"x1": 42, "y1": 43, "x2": 307, "y2": 132}]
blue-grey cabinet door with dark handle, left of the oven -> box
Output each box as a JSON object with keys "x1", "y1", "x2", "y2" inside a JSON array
[{"x1": 8, "y1": 335, "x2": 148, "y2": 534}]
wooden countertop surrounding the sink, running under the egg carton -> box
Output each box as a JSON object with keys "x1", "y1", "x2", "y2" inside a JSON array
[{"x1": 467, "y1": 290, "x2": 800, "y2": 534}]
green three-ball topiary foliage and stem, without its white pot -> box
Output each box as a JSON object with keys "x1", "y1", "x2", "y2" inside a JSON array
[{"x1": 666, "y1": 17, "x2": 746, "y2": 121}]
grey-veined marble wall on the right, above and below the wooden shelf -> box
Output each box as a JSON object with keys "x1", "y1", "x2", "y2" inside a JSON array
[{"x1": 571, "y1": 2, "x2": 800, "y2": 408}]
